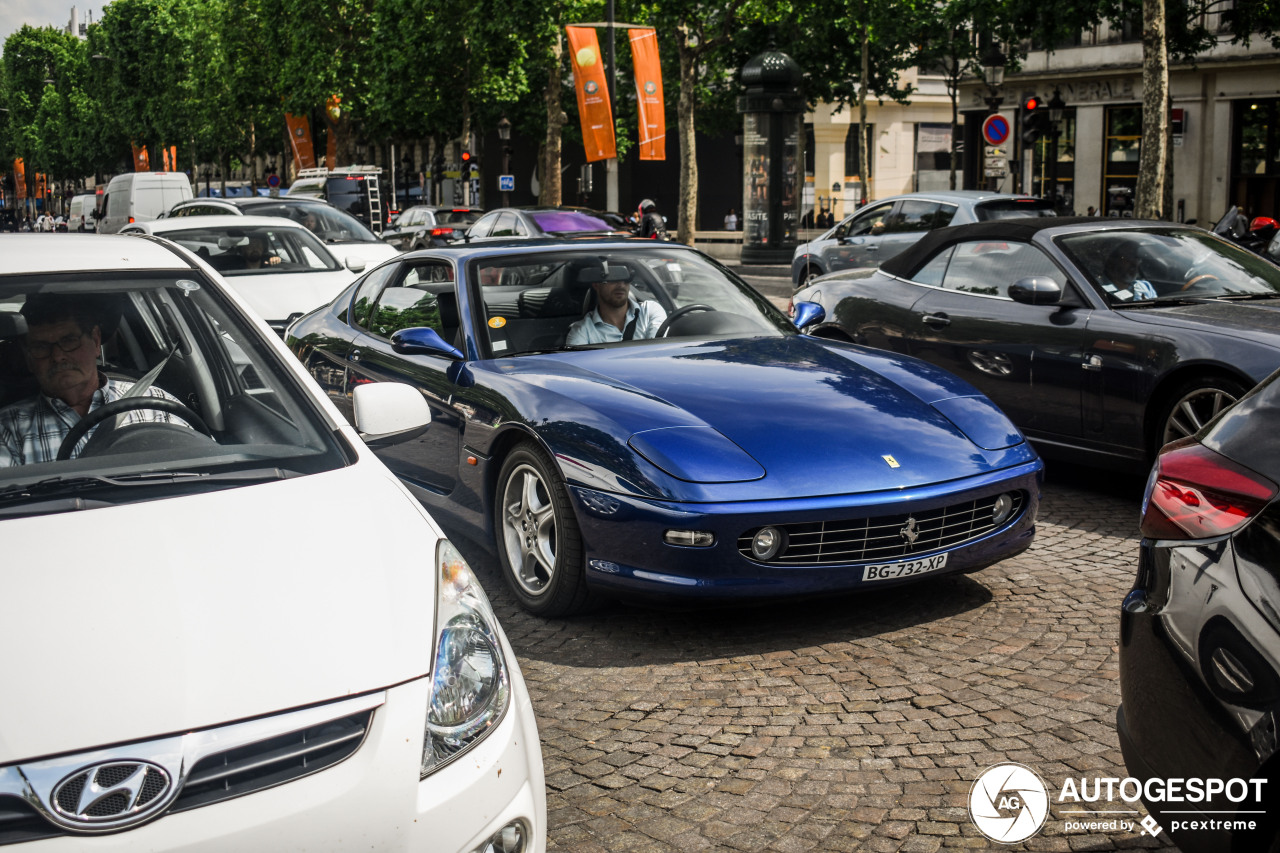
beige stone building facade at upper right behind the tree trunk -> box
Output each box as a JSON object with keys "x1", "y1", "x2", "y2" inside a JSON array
[{"x1": 961, "y1": 22, "x2": 1280, "y2": 225}]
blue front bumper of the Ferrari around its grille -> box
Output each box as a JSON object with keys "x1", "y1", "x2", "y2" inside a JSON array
[{"x1": 570, "y1": 460, "x2": 1043, "y2": 599}]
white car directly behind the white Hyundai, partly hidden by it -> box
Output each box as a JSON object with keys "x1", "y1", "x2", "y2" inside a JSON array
[{"x1": 120, "y1": 216, "x2": 365, "y2": 333}]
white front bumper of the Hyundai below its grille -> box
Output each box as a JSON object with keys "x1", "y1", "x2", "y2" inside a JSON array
[{"x1": 21, "y1": 666, "x2": 547, "y2": 853}]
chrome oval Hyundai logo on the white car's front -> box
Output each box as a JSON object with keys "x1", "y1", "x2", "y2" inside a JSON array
[{"x1": 52, "y1": 761, "x2": 173, "y2": 830}]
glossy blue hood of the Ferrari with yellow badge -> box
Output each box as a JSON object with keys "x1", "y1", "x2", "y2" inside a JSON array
[{"x1": 499, "y1": 336, "x2": 1029, "y2": 497}]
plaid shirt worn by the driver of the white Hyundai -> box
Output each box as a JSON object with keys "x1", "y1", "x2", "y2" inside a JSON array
[{"x1": 0, "y1": 373, "x2": 187, "y2": 467}]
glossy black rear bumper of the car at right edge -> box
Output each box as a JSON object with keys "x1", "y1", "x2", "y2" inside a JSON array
[{"x1": 1116, "y1": 540, "x2": 1280, "y2": 853}]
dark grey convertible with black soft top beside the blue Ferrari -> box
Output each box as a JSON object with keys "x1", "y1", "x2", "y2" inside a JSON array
[{"x1": 792, "y1": 212, "x2": 1280, "y2": 466}]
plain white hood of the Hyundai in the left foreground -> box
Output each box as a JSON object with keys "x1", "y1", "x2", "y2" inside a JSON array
[{"x1": 0, "y1": 460, "x2": 439, "y2": 766}]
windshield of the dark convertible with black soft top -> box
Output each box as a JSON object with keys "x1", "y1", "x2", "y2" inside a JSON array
[{"x1": 1057, "y1": 228, "x2": 1280, "y2": 305}]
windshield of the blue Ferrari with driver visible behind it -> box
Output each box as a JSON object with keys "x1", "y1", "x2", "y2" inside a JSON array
[{"x1": 467, "y1": 246, "x2": 795, "y2": 356}]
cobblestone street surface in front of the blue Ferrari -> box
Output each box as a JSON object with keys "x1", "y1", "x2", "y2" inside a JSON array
[{"x1": 450, "y1": 467, "x2": 1167, "y2": 852}]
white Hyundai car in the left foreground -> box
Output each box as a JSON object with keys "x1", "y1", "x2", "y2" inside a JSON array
[{"x1": 0, "y1": 234, "x2": 547, "y2": 853}]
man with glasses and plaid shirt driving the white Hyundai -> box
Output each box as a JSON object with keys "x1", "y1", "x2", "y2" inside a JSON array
[{"x1": 0, "y1": 295, "x2": 188, "y2": 466}]
